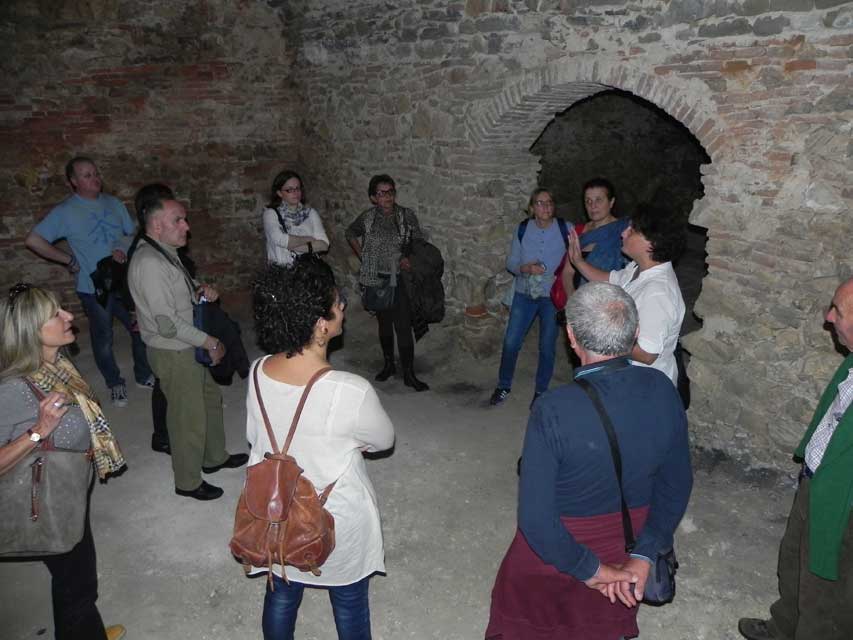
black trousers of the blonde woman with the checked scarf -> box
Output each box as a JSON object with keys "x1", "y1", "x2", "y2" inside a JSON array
[{"x1": 42, "y1": 508, "x2": 107, "y2": 640}]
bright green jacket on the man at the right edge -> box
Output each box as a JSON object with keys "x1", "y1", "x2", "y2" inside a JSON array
[{"x1": 794, "y1": 354, "x2": 853, "y2": 580}]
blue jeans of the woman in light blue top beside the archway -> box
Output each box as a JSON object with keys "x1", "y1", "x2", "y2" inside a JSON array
[{"x1": 498, "y1": 291, "x2": 558, "y2": 393}]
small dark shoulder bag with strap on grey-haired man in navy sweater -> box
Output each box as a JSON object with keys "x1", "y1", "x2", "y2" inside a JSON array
[{"x1": 575, "y1": 378, "x2": 678, "y2": 606}]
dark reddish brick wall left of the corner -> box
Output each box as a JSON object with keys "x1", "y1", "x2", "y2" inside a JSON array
[{"x1": 0, "y1": 0, "x2": 301, "y2": 308}]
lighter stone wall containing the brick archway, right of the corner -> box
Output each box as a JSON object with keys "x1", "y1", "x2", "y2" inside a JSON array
[{"x1": 299, "y1": 0, "x2": 853, "y2": 464}]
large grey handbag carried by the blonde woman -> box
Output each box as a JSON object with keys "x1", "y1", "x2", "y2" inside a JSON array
[{"x1": 0, "y1": 385, "x2": 94, "y2": 558}]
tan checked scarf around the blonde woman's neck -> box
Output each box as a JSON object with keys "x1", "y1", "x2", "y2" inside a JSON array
[{"x1": 30, "y1": 354, "x2": 127, "y2": 480}]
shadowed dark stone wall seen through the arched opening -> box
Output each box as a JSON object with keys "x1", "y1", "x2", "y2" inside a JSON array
[{"x1": 530, "y1": 92, "x2": 709, "y2": 222}]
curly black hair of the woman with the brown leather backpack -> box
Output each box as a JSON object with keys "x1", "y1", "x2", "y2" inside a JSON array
[{"x1": 252, "y1": 254, "x2": 337, "y2": 358}]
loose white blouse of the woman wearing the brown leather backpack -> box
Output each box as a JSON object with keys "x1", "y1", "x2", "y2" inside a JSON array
[{"x1": 246, "y1": 358, "x2": 394, "y2": 586}]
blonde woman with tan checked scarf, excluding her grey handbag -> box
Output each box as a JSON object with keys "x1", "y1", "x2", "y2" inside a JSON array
[{"x1": 0, "y1": 284, "x2": 125, "y2": 640}]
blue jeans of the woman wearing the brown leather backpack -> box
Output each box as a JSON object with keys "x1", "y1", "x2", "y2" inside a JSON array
[{"x1": 262, "y1": 576, "x2": 371, "y2": 640}]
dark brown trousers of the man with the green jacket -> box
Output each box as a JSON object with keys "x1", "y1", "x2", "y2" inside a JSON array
[{"x1": 769, "y1": 478, "x2": 853, "y2": 640}]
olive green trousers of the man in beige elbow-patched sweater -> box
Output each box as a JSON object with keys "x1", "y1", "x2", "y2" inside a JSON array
[{"x1": 148, "y1": 347, "x2": 228, "y2": 491}]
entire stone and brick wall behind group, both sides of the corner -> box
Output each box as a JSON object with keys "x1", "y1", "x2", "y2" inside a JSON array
[{"x1": 0, "y1": 0, "x2": 853, "y2": 464}]
